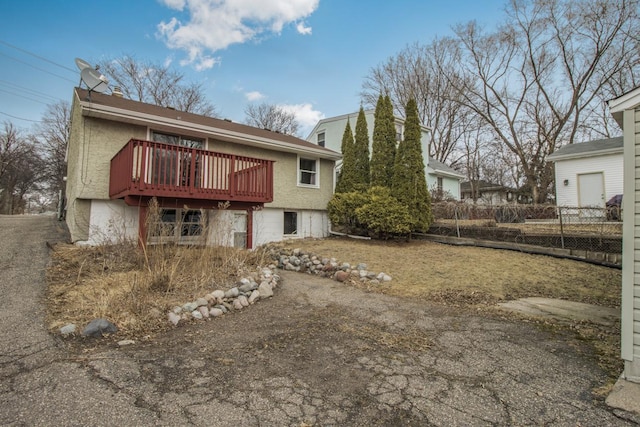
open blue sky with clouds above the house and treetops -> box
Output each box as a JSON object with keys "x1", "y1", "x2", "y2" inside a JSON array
[{"x1": 0, "y1": 0, "x2": 505, "y2": 138}]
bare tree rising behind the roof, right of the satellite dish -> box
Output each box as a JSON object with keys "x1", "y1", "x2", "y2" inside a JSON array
[{"x1": 99, "y1": 55, "x2": 217, "y2": 117}]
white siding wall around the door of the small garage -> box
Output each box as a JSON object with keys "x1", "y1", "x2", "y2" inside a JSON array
[{"x1": 555, "y1": 153, "x2": 624, "y2": 206}]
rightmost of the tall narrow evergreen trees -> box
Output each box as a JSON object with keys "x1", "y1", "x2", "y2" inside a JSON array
[{"x1": 391, "y1": 98, "x2": 433, "y2": 232}]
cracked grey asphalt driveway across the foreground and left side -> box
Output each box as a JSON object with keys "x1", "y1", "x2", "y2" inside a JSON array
[{"x1": 0, "y1": 217, "x2": 637, "y2": 426}]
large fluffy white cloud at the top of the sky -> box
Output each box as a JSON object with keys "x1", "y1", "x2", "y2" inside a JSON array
[{"x1": 158, "y1": 0, "x2": 320, "y2": 70}]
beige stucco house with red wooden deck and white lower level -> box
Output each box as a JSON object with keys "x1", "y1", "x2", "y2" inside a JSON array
[{"x1": 66, "y1": 88, "x2": 341, "y2": 248}]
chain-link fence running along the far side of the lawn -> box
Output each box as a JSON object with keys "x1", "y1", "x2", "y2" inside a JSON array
[{"x1": 429, "y1": 202, "x2": 622, "y2": 254}]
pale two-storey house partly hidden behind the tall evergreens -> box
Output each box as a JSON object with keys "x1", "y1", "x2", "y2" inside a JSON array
[{"x1": 307, "y1": 110, "x2": 464, "y2": 200}]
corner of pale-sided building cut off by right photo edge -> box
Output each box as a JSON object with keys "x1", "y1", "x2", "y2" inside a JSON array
[{"x1": 609, "y1": 88, "x2": 640, "y2": 388}]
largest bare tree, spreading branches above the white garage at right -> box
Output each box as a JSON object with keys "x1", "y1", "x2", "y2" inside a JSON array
[{"x1": 450, "y1": 0, "x2": 639, "y2": 202}]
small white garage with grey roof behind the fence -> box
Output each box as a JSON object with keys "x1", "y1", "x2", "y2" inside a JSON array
[{"x1": 547, "y1": 137, "x2": 623, "y2": 208}]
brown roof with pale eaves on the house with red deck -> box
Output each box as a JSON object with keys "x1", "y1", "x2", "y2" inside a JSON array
[{"x1": 75, "y1": 88, "x2": 342, "y2": 160}]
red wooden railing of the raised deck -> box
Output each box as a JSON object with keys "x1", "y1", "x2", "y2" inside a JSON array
[{"x1": 109, "y1": 139, "x2": 273, "y2": 203}]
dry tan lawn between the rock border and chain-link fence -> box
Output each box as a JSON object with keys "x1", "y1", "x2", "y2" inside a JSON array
[{"x1": 278, "y1": 238, "x2": 621, "y2": 307}]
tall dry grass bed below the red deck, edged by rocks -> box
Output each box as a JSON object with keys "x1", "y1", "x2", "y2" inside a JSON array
[{"x1": 47, "y1": 244, "x2": 268, "y2": 336}]
